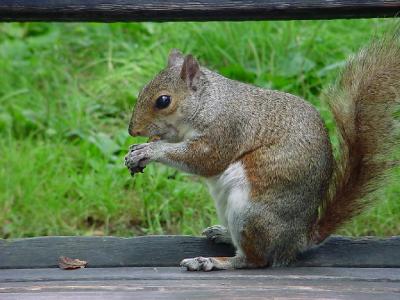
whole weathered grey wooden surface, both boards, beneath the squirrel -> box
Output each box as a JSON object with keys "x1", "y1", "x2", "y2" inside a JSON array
[{"x1": 0, "y1": 236, "x2": 400, "y2": 300}]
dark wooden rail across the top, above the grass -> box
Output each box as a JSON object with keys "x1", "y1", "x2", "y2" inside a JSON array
[{"x1": 0, "y1": 0, "x2": 400, "y2": 22}]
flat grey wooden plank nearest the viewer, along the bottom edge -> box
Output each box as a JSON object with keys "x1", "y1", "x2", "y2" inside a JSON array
[{"x1": 0, "y1": 267, "x2": 400, "y2": 299}]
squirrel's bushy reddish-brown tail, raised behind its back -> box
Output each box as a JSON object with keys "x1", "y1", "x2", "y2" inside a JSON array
[{"x1": 314, "y1": 31, "x2": 400, "y2": 243}]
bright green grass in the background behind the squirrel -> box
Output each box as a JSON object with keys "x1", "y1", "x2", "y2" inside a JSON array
[{"x1": 0, "y1": 20, "x2": 400, "y2": 237}]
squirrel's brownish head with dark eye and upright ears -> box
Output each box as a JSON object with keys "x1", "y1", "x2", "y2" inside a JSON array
[{"x1": 129, "y1": 49, "x2": 201, "y2": 141}]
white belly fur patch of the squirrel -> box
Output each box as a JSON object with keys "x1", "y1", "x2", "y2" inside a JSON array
[{"x1": 207, "y1": 162, "x2": 250, "y2": 245}]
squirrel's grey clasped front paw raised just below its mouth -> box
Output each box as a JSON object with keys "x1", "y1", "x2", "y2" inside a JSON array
[{"x1": 125, "y1": 143, "x2": 152, "y2": 175}]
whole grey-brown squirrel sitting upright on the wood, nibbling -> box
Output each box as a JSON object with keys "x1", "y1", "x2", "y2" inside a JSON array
[{"x1": 125, "y1": 33, "x2": 400, "y2": 271}]
